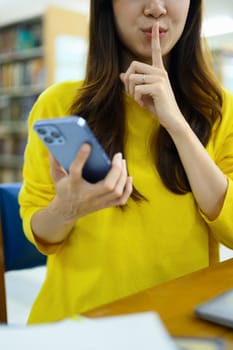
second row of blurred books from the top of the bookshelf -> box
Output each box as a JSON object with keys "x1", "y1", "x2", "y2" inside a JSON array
[{"x1": 0, "y1": 58, "x2": 46, "y2": 88}]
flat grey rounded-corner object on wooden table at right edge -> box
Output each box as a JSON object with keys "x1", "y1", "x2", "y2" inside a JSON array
[{"x1": 195, "y1": 289, "x2": 233, "y2": 328}]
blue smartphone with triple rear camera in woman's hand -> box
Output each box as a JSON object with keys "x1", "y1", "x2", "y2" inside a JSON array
[{"x1": 33, "y1": 116, "x2": 111, "y2": 183}]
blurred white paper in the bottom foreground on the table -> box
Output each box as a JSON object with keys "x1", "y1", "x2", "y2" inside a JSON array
[{"x1": 0, "y1": 312, "x2": 177, "y2": 350}]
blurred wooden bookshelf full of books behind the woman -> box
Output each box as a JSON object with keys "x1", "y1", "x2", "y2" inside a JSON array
[{"x1": 0, "y1": 7, "x2": 88, "y2": 183}]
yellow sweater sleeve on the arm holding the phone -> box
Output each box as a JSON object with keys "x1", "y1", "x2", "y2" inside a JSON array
[{"x1": 19, "y1": 81, "x2": 80, "y2": 254}]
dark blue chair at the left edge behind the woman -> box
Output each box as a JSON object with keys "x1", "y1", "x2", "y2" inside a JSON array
[{"x1": 0, "y1": 183, "x2": 46, "y2": 323}]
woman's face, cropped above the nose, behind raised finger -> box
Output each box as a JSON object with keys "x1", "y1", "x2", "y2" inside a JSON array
[{"x1": 112, "y1": 0, "x2": 190, "y2": 63}]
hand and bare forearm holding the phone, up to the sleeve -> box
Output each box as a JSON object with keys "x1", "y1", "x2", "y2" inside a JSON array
[{"x1": 31, "y1": 144, "x2": 132, "y2": 245}]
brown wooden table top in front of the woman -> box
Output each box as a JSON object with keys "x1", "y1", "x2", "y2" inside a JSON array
[{"x1": 85, "y1": 259, "x2": 233, "y2": 349}]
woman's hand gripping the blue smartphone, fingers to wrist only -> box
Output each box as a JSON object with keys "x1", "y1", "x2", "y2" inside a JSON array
[{"x1": 51, "y1": 144, "x2": 132, "y2": 222}]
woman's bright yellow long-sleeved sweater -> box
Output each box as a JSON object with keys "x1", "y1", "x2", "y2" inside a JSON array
[{"x1": 19, "y1": 81, "x2": 233, "y2": 323}]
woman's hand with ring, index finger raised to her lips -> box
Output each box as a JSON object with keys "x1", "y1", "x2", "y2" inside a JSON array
[{"x1": 120, "y1": 22, "x2": 184, "y2": 134}]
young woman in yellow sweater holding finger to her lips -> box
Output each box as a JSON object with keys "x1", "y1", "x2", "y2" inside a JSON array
[{"x1": 20, "y1": 0, "x2": 233, "y2": 323}]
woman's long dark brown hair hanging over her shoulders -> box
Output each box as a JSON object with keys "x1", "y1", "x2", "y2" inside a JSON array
[{"x1": 71, "y1": 0, "x2": 222, "y2": 200}]
